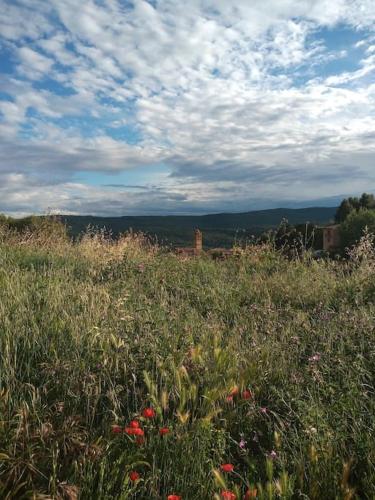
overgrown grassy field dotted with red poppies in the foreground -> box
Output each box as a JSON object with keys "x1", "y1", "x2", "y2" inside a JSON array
[{"x1": 0, "y1": 225, "x2": 375, "y2": 500}]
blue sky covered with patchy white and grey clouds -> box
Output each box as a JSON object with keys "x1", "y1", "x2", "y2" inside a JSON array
[{"x1": 0, "y1": 0, "x2": 375, "y2": 216}]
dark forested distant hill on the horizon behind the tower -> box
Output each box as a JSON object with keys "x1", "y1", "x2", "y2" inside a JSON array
[{"x1": 61, "y1": 207, "x2": 336, "y2": 247}]
